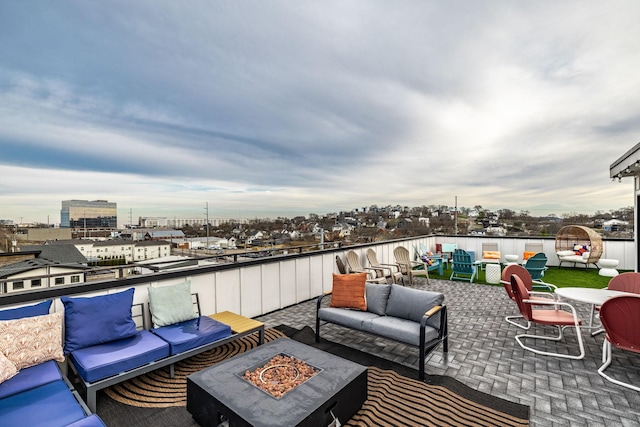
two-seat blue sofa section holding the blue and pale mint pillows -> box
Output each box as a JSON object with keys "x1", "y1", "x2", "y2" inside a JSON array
[{"x1": 61, "y1": 284, "x2": 239, "y2": 412}]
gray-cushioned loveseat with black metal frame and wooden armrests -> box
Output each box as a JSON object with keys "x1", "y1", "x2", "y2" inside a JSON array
[{"x1": 316, "y1": 283, "x2": 448, "y2": 380}]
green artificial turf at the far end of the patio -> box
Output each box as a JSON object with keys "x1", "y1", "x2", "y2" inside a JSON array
[{"x1": 429, "y1": 267, "x2": 622, "y2": 288}]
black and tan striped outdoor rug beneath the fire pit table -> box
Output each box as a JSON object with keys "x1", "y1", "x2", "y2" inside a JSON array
[{"x1": 105, "y1": 329, "x2": 529, "y2": 426}]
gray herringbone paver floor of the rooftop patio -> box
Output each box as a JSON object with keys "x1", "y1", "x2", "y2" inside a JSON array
[{"x1": 257, "y1": 279, "x2": 640, "y2": 426}]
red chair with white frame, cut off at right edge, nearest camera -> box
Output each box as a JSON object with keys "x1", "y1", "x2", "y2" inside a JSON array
[{"x1": 598, "y1": 295, "x2": 640, "y2": 391}]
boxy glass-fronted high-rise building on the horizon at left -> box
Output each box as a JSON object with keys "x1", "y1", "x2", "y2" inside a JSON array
[{"x1": 60, "y1": 200, "x2": 118, "y2": 228}]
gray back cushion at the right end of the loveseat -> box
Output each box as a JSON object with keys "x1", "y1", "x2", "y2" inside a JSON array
[{"x1": 386, "y1": 284, "x2": 444, "y2": 328}]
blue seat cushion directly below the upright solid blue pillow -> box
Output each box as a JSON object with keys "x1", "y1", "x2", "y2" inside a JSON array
[{"x1": 70, "y1": 331, "x2": 169, "y2": 383}]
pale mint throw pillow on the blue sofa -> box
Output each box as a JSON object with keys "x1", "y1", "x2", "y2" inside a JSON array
[{"x1": 149, "y1": 280, "x2": 198, "y2": 328}]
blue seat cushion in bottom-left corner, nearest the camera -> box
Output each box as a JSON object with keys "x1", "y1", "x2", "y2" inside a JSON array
[{"x1": 0, "y1": 380, "x2": 86, "y2": 427}]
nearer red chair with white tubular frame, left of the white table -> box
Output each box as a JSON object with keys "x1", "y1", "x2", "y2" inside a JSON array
[{"x1": 511, "y1": 274, "x2": 584, "y2": 359}]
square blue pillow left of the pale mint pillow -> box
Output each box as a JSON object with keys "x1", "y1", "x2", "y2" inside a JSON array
[{"x1": 60, "y1": 288, "x2": 137, "y2": 353}]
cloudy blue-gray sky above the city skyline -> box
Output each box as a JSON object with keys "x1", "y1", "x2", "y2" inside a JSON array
[{"x1": 0, "y1": 0, "x2": 640, "y2": 223}]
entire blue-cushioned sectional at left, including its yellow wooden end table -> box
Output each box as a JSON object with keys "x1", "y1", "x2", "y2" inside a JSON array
[{"x1": 0, "y1": 283, "x2": 260, "y2": 427}]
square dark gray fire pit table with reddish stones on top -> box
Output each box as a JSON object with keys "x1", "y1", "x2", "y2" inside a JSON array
[{"x1": 187, "y1": 338, "x2": 367, "y2": 427}]
